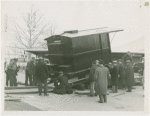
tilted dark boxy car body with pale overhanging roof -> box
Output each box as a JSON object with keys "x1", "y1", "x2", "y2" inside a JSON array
[{"x1": 45, "y1": 29, "x2": 122, "y2": 85}]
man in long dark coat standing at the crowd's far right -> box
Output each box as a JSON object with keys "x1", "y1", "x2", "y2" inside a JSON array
[{"x1": 125, "y1": 60, "x2": 134, "y2": 92}]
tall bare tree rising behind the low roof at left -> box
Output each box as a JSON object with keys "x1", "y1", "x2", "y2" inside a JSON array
[{"x1": 15, "y1": 6, "x2": 48, "y2": 57}]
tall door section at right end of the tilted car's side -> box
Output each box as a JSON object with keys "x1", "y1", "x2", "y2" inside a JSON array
[{"x1": 100, "y1": 33, "x2": 111, "y2": 64}]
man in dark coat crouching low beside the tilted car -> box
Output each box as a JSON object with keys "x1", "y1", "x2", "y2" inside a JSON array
[{"x1": 53, "y1": 71, "x2": 73, "y2": 94}]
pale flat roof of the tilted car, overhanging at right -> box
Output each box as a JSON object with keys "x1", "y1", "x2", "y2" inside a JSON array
[{"x1": 45, "y1": 27, "x2": 123, "y2": 40}]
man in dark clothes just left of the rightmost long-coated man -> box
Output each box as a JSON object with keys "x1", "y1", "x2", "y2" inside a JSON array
[{"x1": 118, "y1": 59, "x2": 125, "y2": 89}]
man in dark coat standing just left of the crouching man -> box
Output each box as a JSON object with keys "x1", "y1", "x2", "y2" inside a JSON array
[{"x1": 35, "y1": 58, "x2": 49, "y2": 96}]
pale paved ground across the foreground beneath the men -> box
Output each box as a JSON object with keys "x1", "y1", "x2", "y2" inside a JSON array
[{"x1": 5, "y1": 87, "x2": 144, "y2": 111}]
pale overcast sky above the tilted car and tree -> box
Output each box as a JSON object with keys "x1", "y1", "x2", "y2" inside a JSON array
[{"x1": 2, "y1": 1, "x2": 149, "y2": 48}]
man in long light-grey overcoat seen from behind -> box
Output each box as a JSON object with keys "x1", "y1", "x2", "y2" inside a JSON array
[{"x1": 94, "y1": 60, "x2": 109, "y2": 103}]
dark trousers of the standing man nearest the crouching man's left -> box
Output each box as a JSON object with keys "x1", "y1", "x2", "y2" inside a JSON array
[{"x1": 38, "y1": 79, "x2": 47, "y2": 95}]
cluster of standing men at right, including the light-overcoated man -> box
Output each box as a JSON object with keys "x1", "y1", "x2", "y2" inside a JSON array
[{"x1": 90, "y1": 52, "x2": 134, "y2": 103}]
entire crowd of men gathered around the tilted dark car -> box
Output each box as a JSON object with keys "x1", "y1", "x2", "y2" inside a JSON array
[{"x1": 6, "y1": 52, "x2": 144, "y2": 103}]
